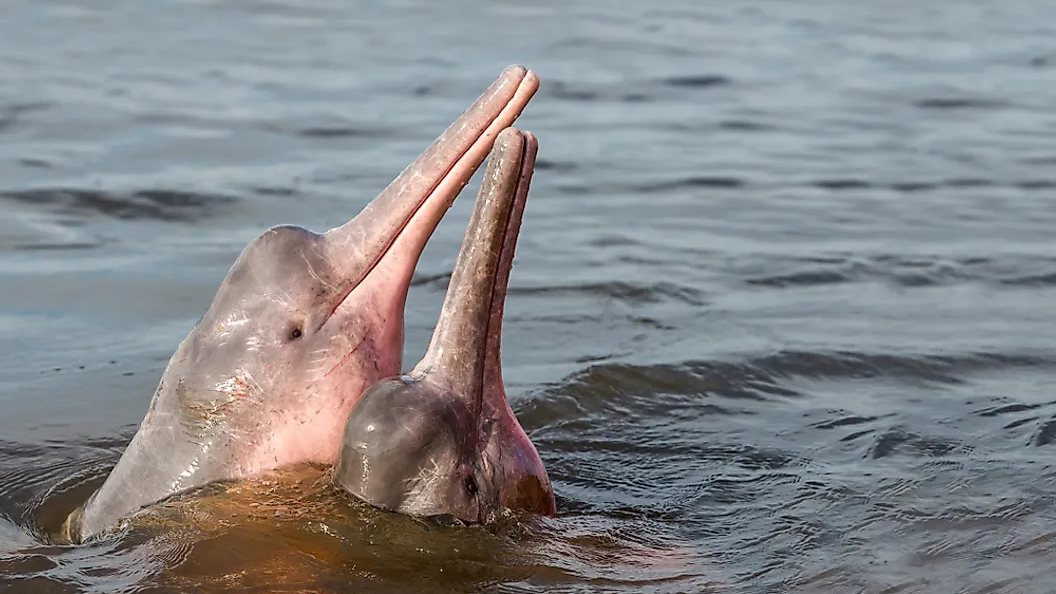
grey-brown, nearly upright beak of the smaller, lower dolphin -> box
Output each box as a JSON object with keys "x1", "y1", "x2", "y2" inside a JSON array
[{"x1": 412, "y1": 128, "x2": 539, "y2": 415}]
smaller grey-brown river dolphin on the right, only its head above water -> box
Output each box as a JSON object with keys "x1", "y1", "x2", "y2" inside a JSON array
[{"x1": 333, "y1": 128, "x2": 555, "y2": 523}]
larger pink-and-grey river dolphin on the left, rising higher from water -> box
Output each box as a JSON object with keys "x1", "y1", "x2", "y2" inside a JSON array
[{"x1": 62, "y1": 67, "x2": 539, "y2": 542}]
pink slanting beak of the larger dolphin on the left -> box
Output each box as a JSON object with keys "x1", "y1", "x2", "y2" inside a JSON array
[{"x1": 326, "y1": 66, "x2": 539, "y2": 312}]
